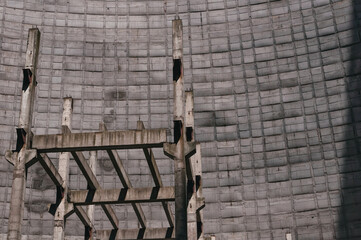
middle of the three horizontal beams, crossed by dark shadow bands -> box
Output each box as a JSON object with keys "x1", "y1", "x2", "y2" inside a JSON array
[{"x1": 69, "y1": 187, "x2": 174, "y2": 205}]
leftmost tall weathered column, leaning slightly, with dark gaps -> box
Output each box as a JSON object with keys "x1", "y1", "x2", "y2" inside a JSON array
[{"x1": 8, "y1": 28, "x2": 40, "y2": 240}]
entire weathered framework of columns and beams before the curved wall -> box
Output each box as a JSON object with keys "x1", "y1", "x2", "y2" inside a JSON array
[{"x1": 6, "y1": 19, "x2": 210, "y2": 240}]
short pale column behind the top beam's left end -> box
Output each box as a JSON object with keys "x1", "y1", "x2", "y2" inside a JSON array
[{"x1": 53, "y1": 97, "x2": 73, "y2": 240}]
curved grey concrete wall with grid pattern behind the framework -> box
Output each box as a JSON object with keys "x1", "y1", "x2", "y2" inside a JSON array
[{"x1": 0, "y1": 0, "x2": 361, "y2": 240}]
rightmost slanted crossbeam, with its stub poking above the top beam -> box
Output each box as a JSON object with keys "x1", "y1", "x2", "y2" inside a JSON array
[{"x1": 137, "y1": 121, "x2": 174, "y2": 227}]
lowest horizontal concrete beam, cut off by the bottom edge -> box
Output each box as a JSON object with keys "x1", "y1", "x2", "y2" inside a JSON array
[{"x1": 96, "y1": 227, "x2": 175, "y2": 240}]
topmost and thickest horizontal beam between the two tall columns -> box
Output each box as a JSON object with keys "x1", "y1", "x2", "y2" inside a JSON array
[{"x1": 32, "y1": 129, "x2": 167, "y2": 152}]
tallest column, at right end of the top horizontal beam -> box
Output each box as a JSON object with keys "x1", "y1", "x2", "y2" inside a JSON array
[{"x1": 172, "y1": 19, "x2": 187, "y2": 240}]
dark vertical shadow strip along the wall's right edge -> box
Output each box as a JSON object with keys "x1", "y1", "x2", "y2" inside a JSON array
[{"x1": 336, "y1": 0, "x2": 361, "y2": 240}]
